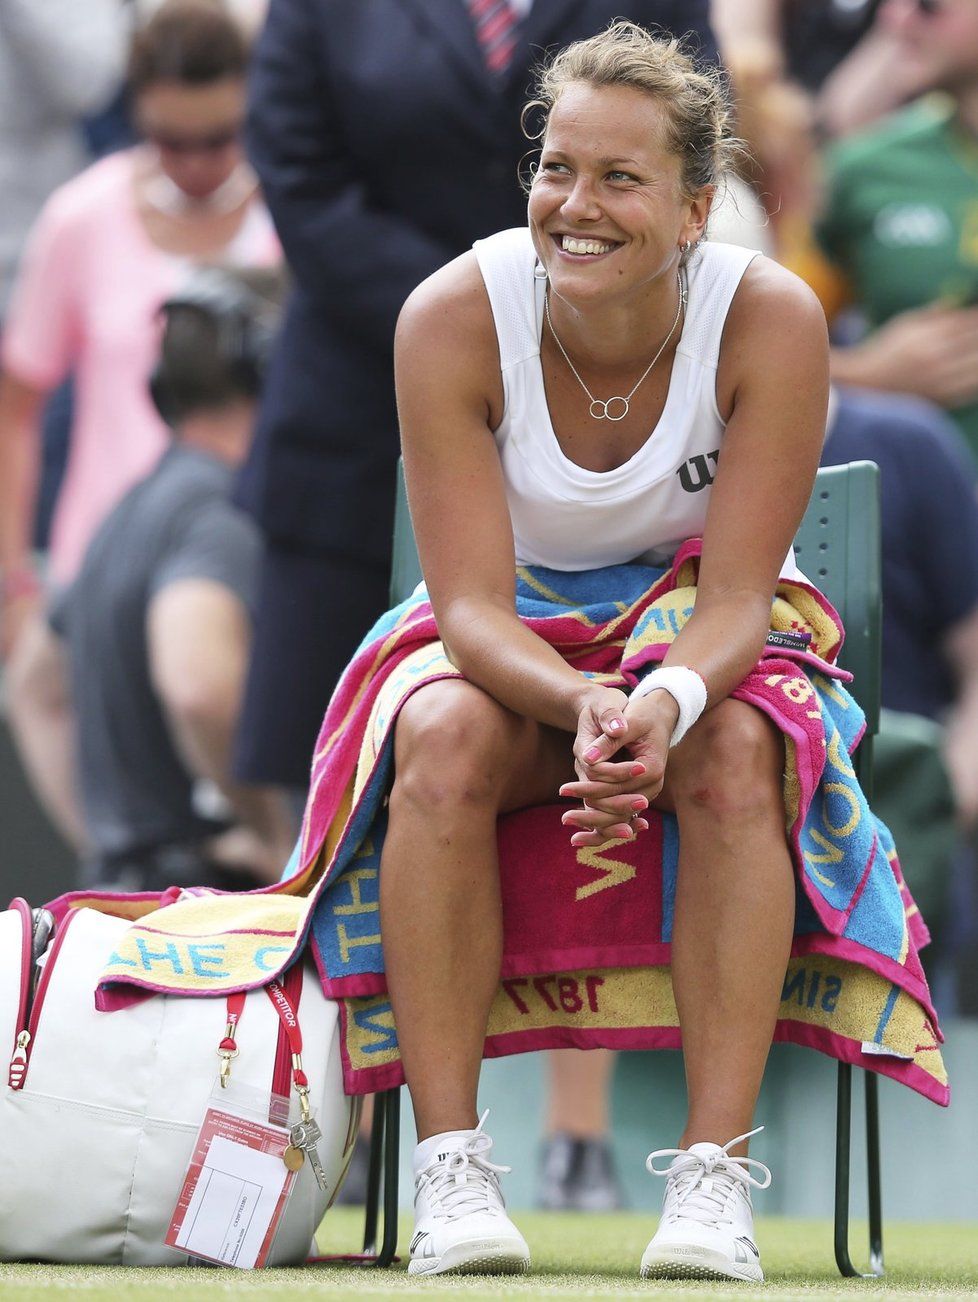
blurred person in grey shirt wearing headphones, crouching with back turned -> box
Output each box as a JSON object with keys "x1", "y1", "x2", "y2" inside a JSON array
[{"x1": 25, "y1": 267, "x2": 294, "y2": 891}]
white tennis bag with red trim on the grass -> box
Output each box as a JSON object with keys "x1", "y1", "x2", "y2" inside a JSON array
[{"x1": 0, "y1": 900, "x2": 359, "y2": 1266}]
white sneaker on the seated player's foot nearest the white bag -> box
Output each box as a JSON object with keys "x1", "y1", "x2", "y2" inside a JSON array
[{"x1": 408, "y1": 1112, "x2": 530, "y2": 1275}]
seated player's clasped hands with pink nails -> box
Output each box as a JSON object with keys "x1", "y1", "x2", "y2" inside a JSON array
[{"x1": 560, "y1": 686, "x2": 678, "y2": 846}]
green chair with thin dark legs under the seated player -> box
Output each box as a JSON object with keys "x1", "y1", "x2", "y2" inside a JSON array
[{"x1": 363, "y1": 461, "x2": 883, "y2": 1276}]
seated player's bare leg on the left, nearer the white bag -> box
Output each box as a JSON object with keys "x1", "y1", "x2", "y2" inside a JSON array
[{"x1": 380, "y1": 681, "x2": 573, "y2": 1139}]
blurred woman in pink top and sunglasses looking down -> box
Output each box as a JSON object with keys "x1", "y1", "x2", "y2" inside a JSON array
[{"x1": 0, "y1": 0, "x2": 280, "y2": 845}]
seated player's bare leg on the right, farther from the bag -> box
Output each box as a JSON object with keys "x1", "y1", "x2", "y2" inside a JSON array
[{"x1": 667, "y1": 700, "x2": 794, "y2": 1151}]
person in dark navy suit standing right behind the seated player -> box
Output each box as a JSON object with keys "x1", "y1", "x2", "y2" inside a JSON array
[{"x1": 238, "y1": 0, "x2": 716, "y2": 786}]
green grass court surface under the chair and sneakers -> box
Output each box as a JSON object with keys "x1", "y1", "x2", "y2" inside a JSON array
[{"x1": 0, "y1": 1208, "x2": 978, "y2": 1302}]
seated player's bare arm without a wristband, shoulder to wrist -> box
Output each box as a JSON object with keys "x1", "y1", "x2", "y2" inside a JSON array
[{"x1": 395, "y1": 254, "x2": 621, "y2": 732}]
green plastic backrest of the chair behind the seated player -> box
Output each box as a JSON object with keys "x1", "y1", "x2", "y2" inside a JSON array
[{"x1": 391, "y1": 461, "x2": 882, "y2": 736}]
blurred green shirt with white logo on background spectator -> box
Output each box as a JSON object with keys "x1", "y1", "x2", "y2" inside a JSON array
[{"x1": 817, "y1": 96, "x2": 978, "y2": 456}]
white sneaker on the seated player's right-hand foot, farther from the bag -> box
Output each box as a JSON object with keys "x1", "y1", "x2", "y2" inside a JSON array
[{"x1": 642, "y1": 1126, "x2": 771, "y2": 1284}]
